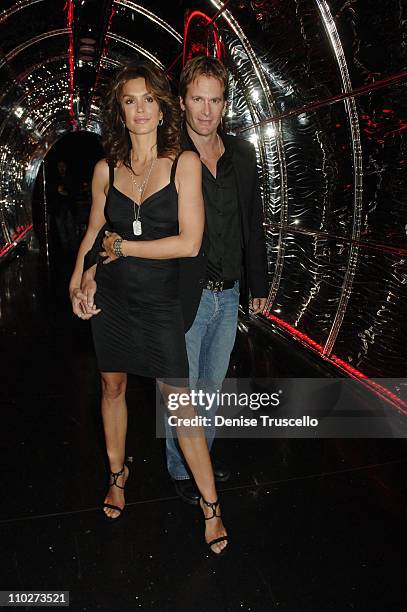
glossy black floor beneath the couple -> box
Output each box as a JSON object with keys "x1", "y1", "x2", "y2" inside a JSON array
[{"x1": 0, "y1": 241, "x2": 407, "y2": 612}]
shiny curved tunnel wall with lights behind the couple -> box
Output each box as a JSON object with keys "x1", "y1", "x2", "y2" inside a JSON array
[{"x1": 0, "y1": 0, "x2": 407, "y2": 377}]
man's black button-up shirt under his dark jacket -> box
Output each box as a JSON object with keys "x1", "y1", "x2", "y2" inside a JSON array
[{"x1": 183, "y1": 128, "x2": 242, "y2": 280}]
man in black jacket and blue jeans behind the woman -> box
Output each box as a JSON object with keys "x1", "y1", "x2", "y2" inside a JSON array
[{"x1": 76, "y1": 56, "x2": 268, "y2": 504}]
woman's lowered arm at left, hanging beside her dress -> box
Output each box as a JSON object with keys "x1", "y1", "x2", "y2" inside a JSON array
[{"x1": 69, "y1": 159, "x2": 109, "y2": 314}]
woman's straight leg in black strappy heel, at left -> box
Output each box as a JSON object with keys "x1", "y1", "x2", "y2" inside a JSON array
[{"x1": 101, "y1": 372, "x2": 129, "y2": 519}]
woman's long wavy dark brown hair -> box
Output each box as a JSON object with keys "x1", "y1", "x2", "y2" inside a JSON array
[{"x1": 102, "y1": 59, "x2": 181, "y2": 168}]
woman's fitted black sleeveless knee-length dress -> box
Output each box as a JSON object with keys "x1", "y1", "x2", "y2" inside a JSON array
[{"x1": 91, "y1": 160, "x2": 188, "y2": 379}]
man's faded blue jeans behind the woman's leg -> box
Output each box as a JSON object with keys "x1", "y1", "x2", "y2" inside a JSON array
[{"x1": 165, "y1": 281, "x2": 239, "y2": 480}]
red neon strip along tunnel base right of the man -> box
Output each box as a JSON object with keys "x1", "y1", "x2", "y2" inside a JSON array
[{"x1": 265, "y1": 314, "x2": 407, "y2": 416}]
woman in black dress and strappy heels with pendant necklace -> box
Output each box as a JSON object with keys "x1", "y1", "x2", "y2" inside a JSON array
[{"x1": 70, "y1": 61, "x2": 227, "y2": 554}]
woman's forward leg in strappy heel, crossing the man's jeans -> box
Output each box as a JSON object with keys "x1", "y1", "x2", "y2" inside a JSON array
[{"x1": 158, "y1": 382, "x2": 227, "y2": 554}]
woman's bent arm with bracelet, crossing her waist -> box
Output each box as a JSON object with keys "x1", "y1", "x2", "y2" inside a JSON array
[{"x1": 102, "y1": 151, "x2": 205, "y2": 263}]
